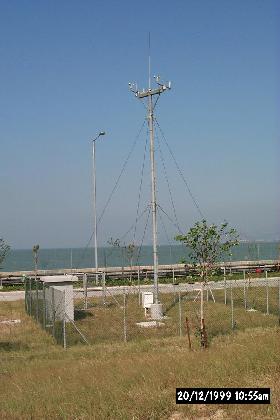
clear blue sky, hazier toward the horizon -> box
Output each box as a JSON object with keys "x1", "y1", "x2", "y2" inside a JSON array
[{"x1": 0, "y1": 0, "x2": 280, "y2": 248}]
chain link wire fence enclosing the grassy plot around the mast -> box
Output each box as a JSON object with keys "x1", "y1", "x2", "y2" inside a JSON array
[{"x1": 25, "y1": 272, "x2": 280, "y2": 348}]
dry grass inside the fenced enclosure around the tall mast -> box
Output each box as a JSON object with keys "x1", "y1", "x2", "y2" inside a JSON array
[{"x1": 67, "y1": 287, "x2": 279, "y2": 348}]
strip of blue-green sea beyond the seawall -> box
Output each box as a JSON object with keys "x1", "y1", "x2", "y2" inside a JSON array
[{"x1": 1, "y1": 242, "x2": 280, "y2": 271}]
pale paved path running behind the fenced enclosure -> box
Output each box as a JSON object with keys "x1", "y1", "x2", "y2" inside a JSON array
[{"x1": 0, "y1": 277, "x2": 280, "y2": 302}]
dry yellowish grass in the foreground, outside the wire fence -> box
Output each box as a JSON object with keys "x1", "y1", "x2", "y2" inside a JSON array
[{"x1": 0, "y1": 300, "x2": 280, "y2": 420}]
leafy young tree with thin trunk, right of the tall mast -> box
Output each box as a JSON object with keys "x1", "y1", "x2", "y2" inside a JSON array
[{"x1": 175, "y1": 219, "x2": 239, "y2": 347}]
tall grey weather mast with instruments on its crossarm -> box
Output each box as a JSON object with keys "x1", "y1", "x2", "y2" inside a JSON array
[{"x1": 129, "y1": 60, "x2": 171, "y2": 319}]
